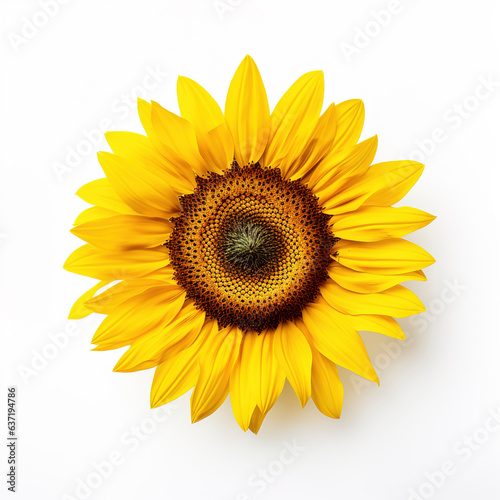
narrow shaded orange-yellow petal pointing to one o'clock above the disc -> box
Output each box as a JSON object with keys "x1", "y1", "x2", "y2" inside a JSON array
[{"x1": 280, "y1": 104, "x2": 337, "y2": 180}]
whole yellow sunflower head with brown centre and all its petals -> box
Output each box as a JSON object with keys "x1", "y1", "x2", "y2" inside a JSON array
[{"x1": 64, "y1": 56, "x2": 434, "y2": 433}]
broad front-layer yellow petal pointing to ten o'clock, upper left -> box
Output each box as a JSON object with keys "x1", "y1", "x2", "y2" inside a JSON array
[{"x1": 97, "y1": 152, "x2": 180, "y2": 219}]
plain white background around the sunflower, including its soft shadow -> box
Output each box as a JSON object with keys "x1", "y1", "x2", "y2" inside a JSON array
[{"x1": 0, "y1": 0, "x2": 500, "y2": 500}]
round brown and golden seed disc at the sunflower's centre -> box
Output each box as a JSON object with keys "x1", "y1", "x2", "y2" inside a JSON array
[{"x1": 165, "y1": 162, "x2": 338, "y2": 333}]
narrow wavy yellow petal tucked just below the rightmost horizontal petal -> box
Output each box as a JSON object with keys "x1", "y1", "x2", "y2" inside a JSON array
[{"x1": 320, "y1": 279, "x2": 425, "y2": 318}]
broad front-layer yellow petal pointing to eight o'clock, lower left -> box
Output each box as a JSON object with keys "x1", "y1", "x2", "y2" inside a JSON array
[{"x1": 92, "y1": 285, "x2": 186, "y2": 350}]
